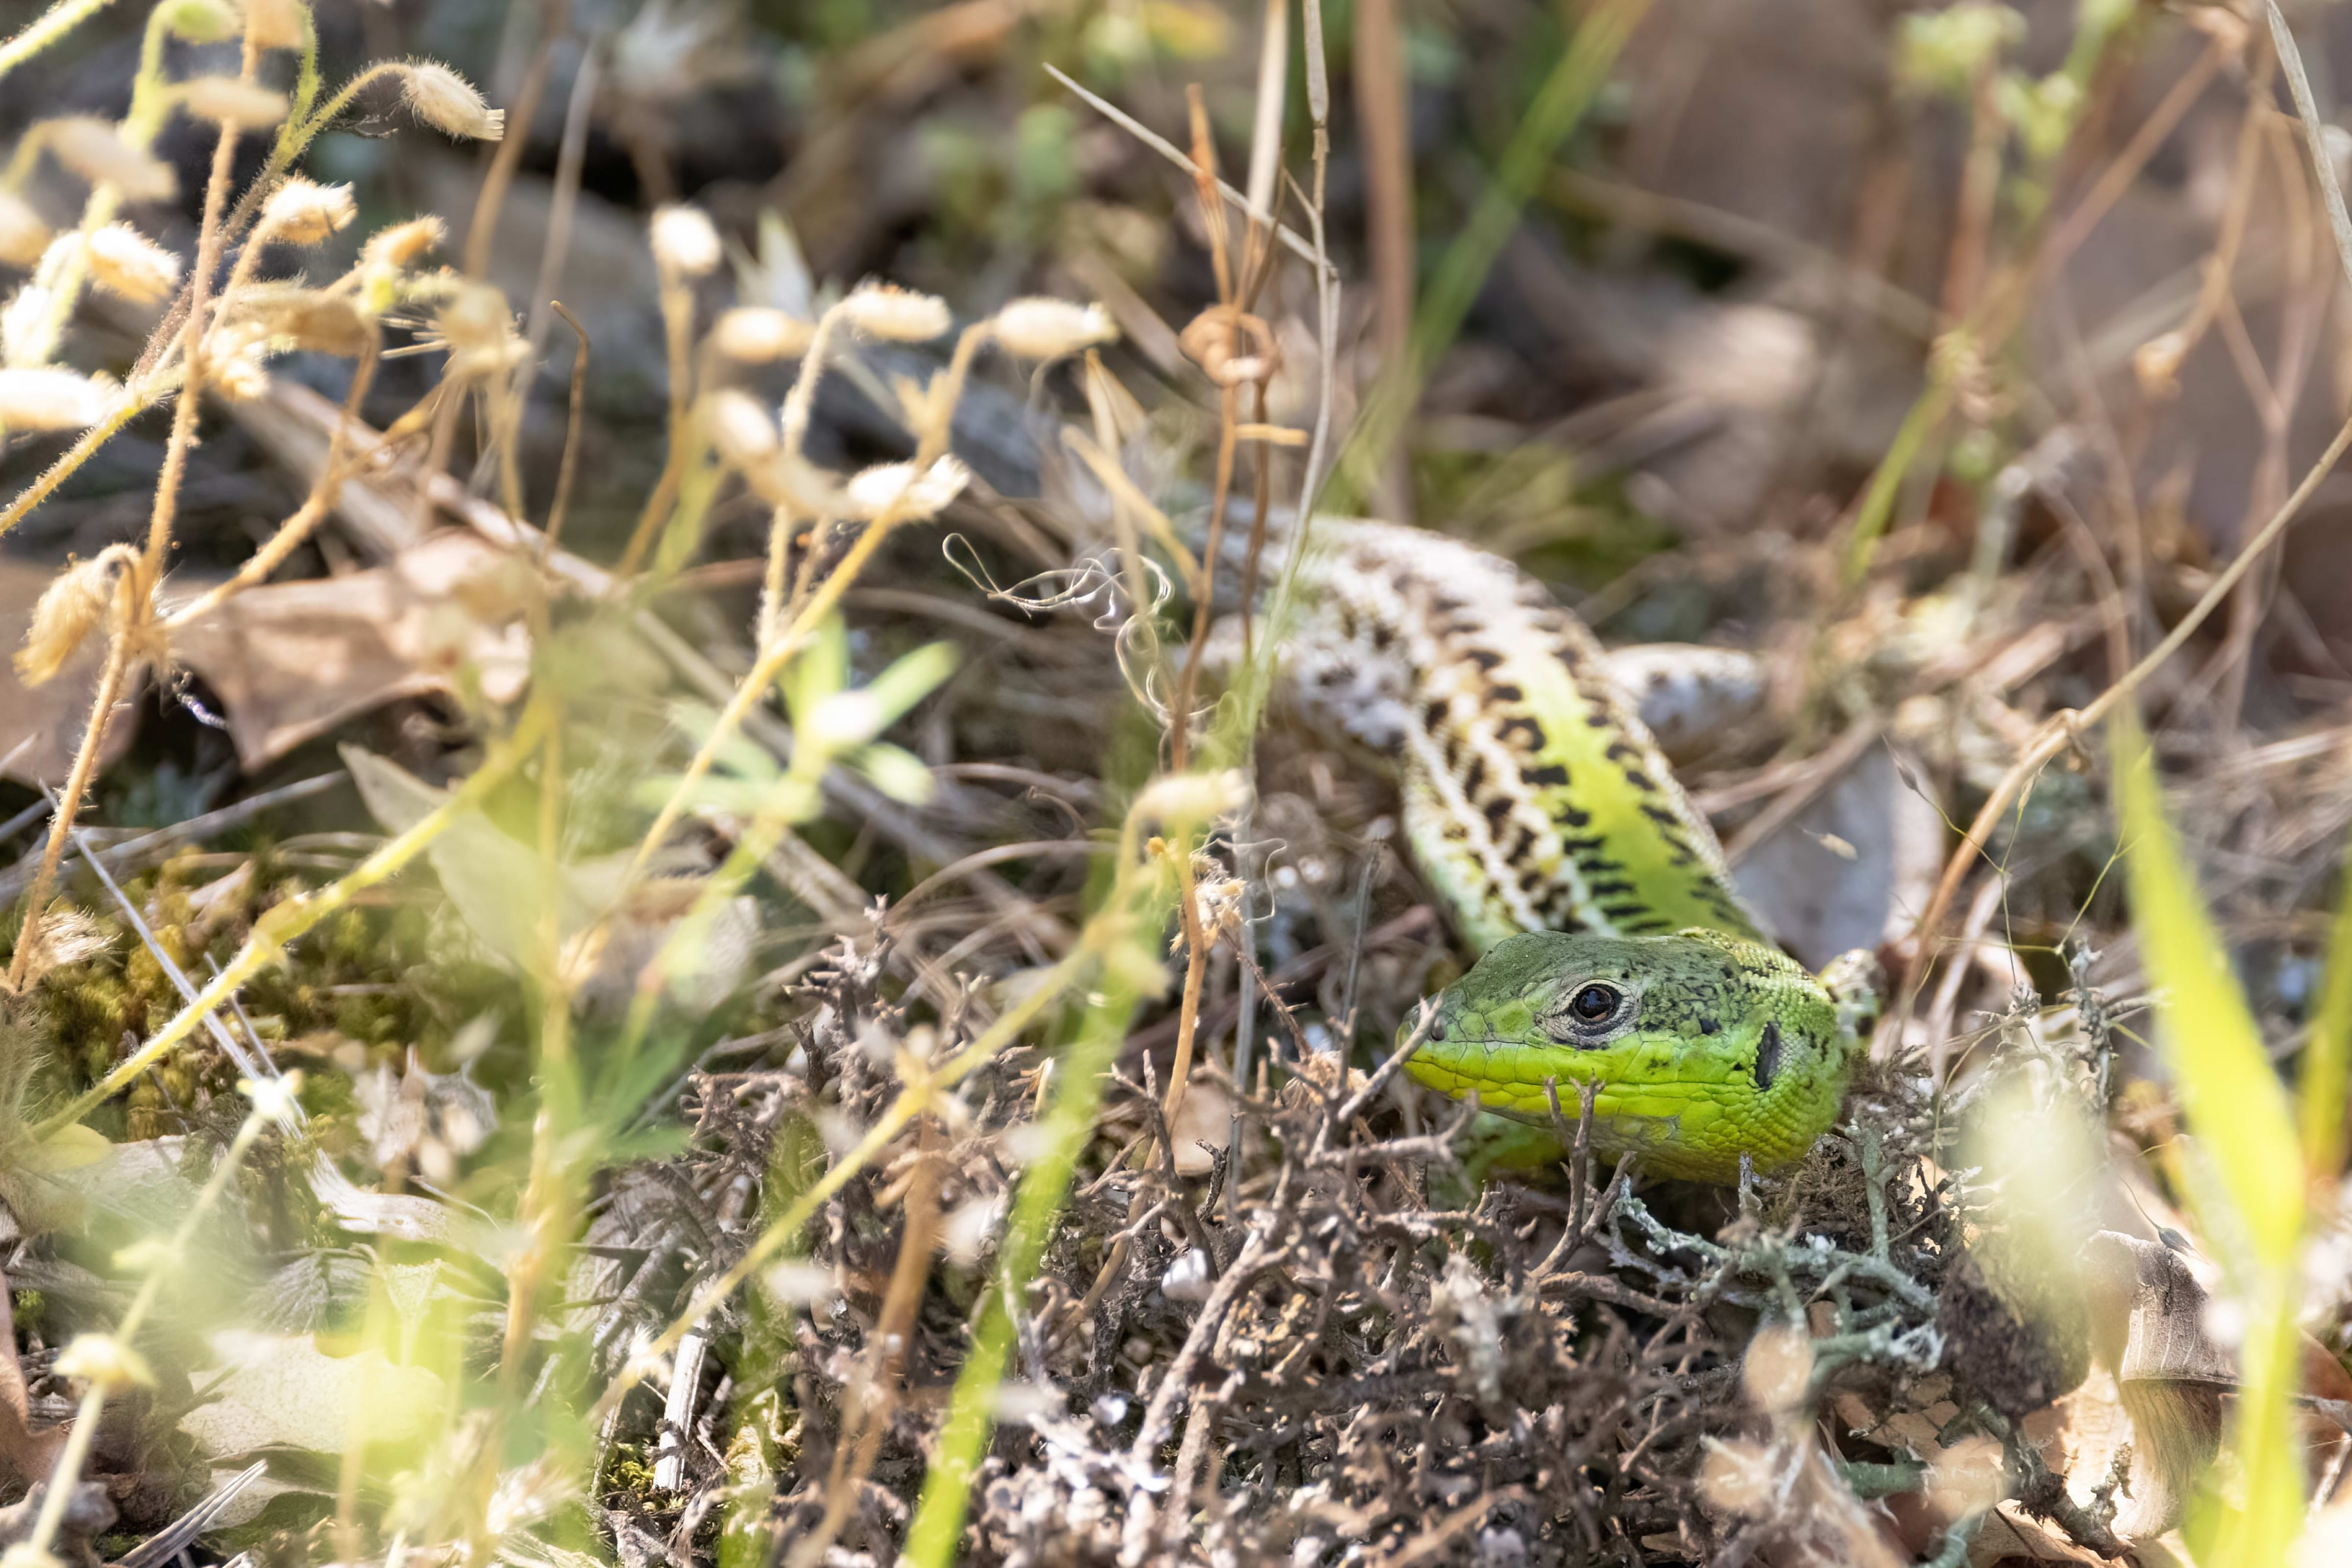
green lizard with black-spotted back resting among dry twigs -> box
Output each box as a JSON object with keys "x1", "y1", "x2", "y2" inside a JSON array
[{"x1": 1282, "y1": 520, "x2": 1877, "y2": 1182}]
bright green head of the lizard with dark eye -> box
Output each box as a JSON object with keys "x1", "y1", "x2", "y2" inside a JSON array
[{"x1": 1406, "y1": 929, "x2": 1853, "y2": 1182}]
